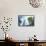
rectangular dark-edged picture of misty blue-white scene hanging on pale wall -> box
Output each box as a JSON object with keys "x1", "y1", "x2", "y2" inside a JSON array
[{"x1": 18, "y1": 15, "x2": 34, "y2": 26}]
